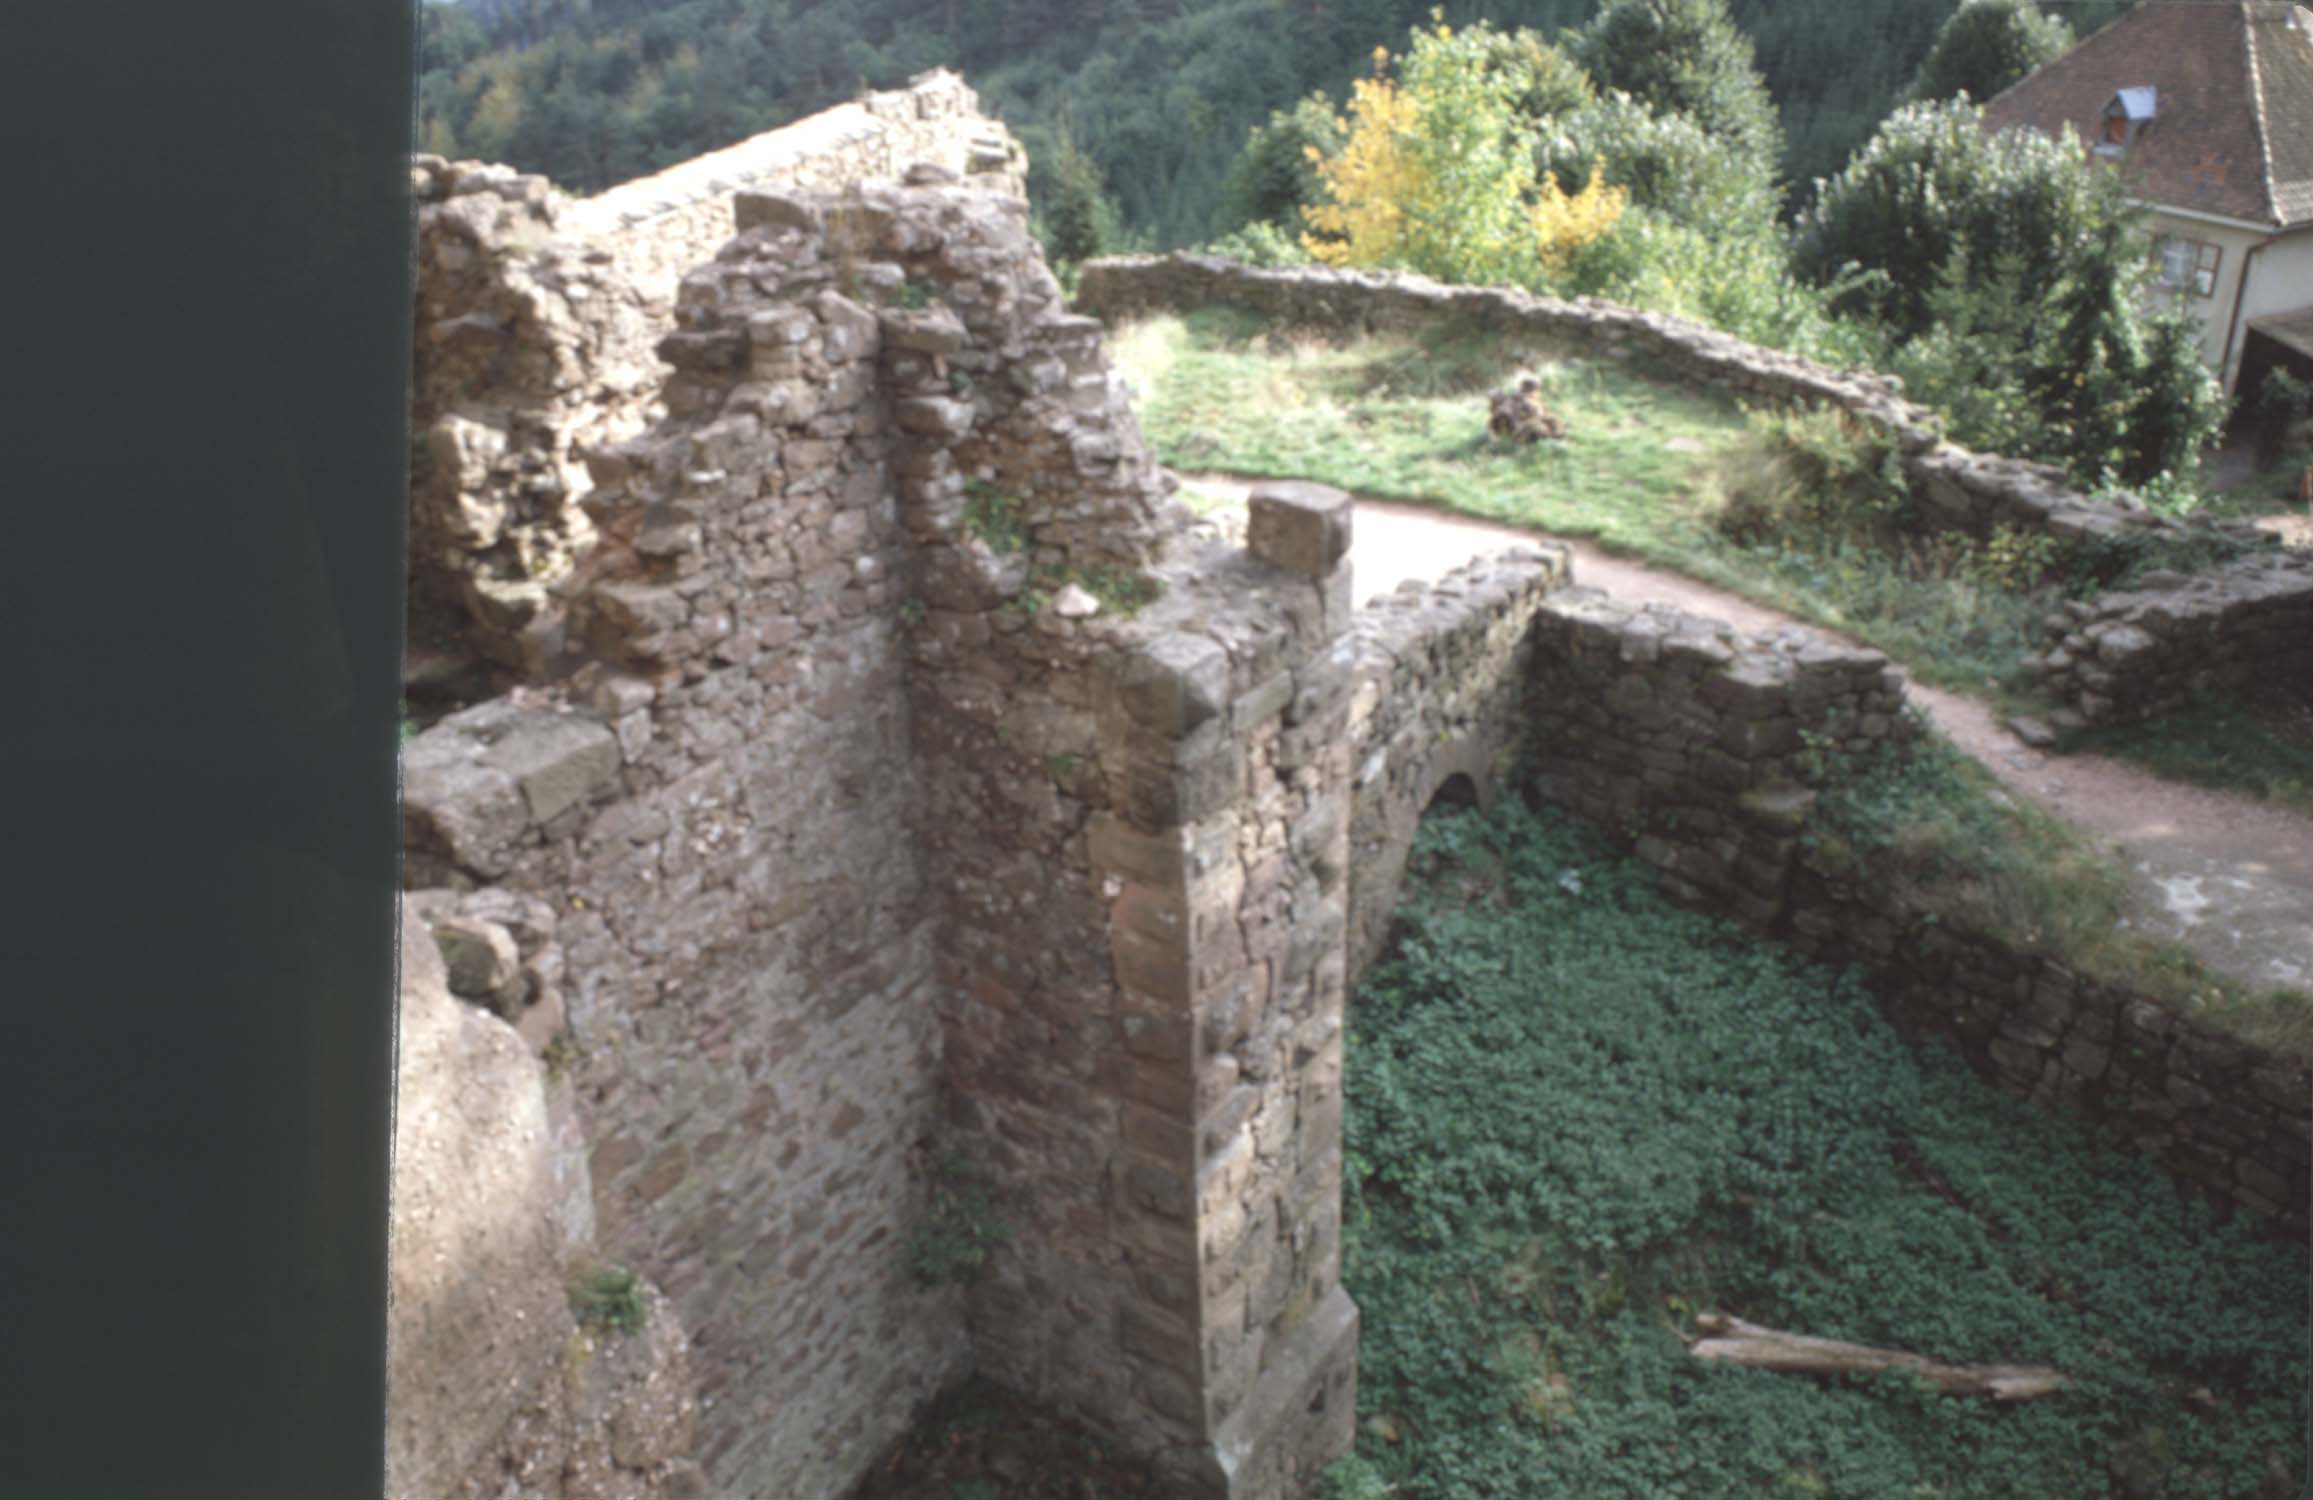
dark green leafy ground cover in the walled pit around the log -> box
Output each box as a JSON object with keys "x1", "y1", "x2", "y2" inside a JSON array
[{"x1": 1328, "y1": 802, "x2": 2308, "y2": 1500}]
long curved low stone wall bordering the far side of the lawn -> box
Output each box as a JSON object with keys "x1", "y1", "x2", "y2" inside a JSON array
[{"x1": 1076, "y1": 254, "x2": 2229, "y2": 561}]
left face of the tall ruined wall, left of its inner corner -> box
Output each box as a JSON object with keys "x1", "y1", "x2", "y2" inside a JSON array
[{"x1": 405, "y1": 196, "x2": 965, "y2": 1498}]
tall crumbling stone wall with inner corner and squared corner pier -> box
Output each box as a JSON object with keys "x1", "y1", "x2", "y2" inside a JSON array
[{"x1": 405, "y1": 177, "x2": 1355, "y2": 1498}]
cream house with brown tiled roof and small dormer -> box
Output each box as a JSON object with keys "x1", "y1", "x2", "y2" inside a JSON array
[{"x1": 1985, "y1": 0, "x2": 2313, "y2": 398}]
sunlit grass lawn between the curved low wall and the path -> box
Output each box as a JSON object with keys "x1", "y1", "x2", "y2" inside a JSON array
[{"x1": 1110, "y1": 307, "x2": 2059, "y2": 693}]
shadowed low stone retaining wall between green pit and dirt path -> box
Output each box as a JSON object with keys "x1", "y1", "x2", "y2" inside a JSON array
[{"x1": 1536, "y1": 589, "x2": 2313, "y2": 1234}]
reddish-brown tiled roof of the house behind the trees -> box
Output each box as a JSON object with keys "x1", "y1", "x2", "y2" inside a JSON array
[{"x1": 1985, "y1": 0, "x2": 2313, "y2": 229}]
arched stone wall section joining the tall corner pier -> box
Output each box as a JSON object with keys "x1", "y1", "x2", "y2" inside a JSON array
[{"x1": 1348, "y1": 543, "x2": 1573, "y2": 982}]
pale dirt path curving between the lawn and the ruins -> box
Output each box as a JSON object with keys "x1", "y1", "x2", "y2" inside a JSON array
[{"x1": 1182, "y1": 474, "x2": 2313, "y2": 987}]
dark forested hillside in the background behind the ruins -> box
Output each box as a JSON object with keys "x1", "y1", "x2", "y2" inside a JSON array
[{"x1": 419, "y1": 0, "x2": 2126, "y2": 247}]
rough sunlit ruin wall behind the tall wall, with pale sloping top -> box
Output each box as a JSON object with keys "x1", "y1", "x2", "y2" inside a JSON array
[{"x1": 409, "y1": 72, "x2": 1027, "y2": 698}]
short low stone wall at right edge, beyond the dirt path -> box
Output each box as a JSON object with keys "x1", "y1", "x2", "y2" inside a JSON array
[{"x1": 2033, "y1": 552, "x2": 2313, "y2": 723}]
